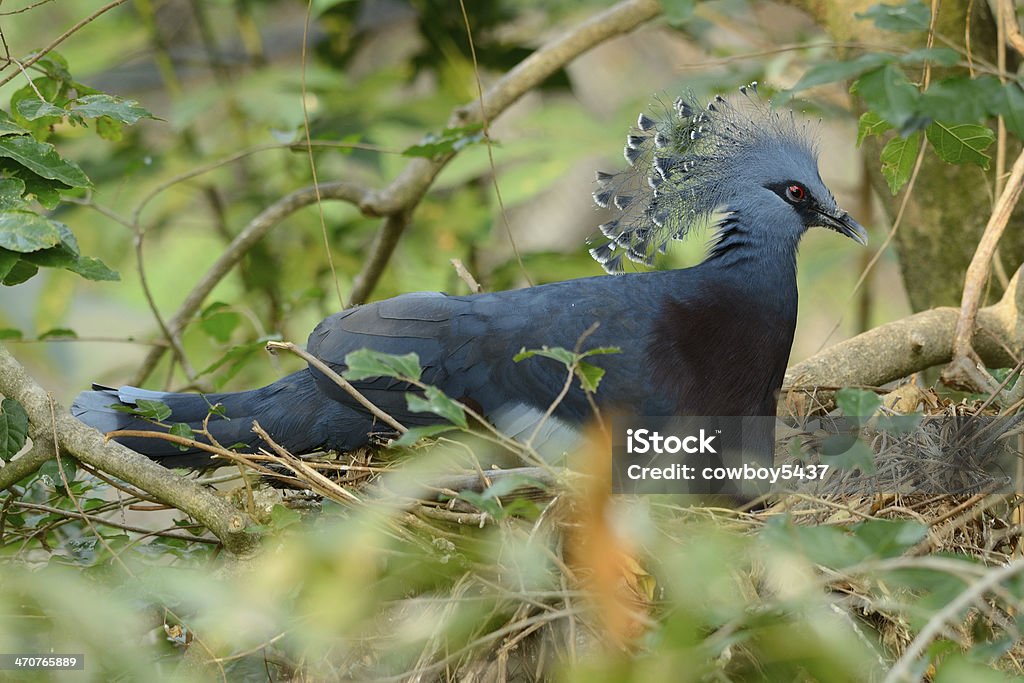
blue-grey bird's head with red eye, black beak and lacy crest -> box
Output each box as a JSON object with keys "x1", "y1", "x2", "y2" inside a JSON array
[{"x1": 590, "y1": 84, "x2": 867, "y2": 272}]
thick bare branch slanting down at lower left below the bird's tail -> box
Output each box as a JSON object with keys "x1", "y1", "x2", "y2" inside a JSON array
[{"x1": 0, "y1": 346, "x2": 259, "y2": 557}]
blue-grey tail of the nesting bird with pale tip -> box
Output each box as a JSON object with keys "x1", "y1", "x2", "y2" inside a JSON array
[{"x1": 71, "y1": 370, "x2": 326, "y2": 468}]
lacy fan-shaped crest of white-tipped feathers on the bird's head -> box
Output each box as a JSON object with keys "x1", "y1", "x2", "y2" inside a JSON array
[{"x1": 590, "y1": 83, "x2": 814, "y2": 273}]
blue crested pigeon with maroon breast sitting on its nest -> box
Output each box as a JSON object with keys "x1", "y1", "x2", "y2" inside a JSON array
[{"x1": 72, "y1": 84, "x2": 866, "y2": 467}]
